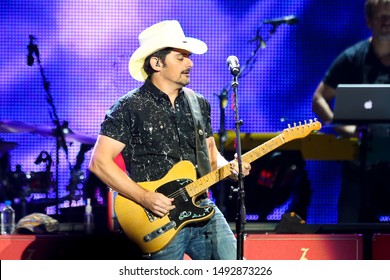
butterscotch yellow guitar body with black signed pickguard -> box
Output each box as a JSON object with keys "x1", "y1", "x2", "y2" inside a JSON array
[{"x1": 115, "y1": 161, "x2": 214, "y2": 253}]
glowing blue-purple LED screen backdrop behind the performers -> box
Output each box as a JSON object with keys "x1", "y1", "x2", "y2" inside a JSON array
[{"x1": 0, "y1": 0, "x2": 370, "y2": 223}]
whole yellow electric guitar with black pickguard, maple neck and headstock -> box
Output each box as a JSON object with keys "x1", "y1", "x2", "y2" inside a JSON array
[{"x1": 114, "y1": 120, "x2": 321, "y2": 253}]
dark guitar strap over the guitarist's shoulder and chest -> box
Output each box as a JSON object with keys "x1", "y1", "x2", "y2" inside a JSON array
[{"x1": 183, "y1": 87, "x2": 211, "y2": 176}]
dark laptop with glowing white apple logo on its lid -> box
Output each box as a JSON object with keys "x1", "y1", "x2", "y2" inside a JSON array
[{"x1": 332, "y1": 84, "x2": 390, "y2": 125}]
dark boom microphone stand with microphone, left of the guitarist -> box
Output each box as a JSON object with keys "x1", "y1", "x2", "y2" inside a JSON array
[{"x1": 27, "y1": 35, "x2": 70, "y2": 215}]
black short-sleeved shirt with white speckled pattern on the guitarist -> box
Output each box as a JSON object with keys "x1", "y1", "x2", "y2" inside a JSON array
[{"x1": 100, "y1": 79, "x2": 212, "y2": 182}]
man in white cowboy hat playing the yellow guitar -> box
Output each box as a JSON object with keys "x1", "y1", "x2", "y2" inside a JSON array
[{"x1": 89, "y1": 20, "x2": 251, "y2": 260}]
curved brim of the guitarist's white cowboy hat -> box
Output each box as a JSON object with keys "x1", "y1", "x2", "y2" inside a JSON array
[{"x1": 129, "y1": 37, "x2": 207, "y2": 82}]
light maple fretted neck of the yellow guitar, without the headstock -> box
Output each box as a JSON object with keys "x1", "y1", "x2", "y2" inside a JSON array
[{"x1": 185, "y1": 134, "x2": 287, "y2": 197}]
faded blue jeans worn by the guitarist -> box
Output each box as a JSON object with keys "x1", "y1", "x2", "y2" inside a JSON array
[{"x1": 146, "y1": 199, "x2": 237, "y2": 260}]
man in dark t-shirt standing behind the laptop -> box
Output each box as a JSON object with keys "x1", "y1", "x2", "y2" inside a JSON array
[{"x1": 312, "y1": 0, "x2": 390, "y2": 222}]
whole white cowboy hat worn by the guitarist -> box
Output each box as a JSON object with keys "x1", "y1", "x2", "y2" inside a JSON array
[{"x1": 129, "y1": 20, "x2": 207, "y2": 81}]
